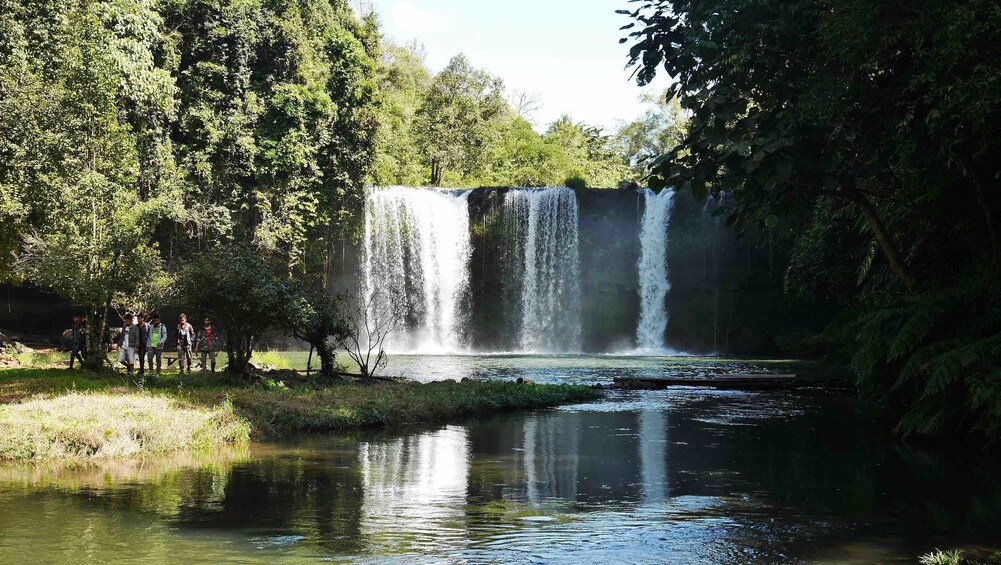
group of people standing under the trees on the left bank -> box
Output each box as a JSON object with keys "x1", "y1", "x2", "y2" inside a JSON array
[{"x1": 69, "y1": 314, "x2": 222, "y2": 378}]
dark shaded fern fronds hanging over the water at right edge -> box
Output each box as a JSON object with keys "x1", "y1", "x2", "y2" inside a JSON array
[{"x1": 841, "y1": 277, "x2": 1001, "y2": 437}]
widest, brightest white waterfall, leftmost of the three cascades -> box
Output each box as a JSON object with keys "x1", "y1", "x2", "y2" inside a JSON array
[{"x1": 362, "y1": 186, "x2": 471, "y2": 353}]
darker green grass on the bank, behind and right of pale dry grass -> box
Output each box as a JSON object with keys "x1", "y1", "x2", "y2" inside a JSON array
[{"x1": 0, "y1": 369, "x2": 602, "y2": 448}]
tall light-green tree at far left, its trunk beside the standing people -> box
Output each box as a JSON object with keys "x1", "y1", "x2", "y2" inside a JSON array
[{"x1": 0, "y1": 1, "x2": 173, "y2": 369}]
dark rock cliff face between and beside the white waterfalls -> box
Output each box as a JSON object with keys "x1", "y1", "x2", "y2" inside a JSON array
[{"x1": 0, "y1": 187, "x2": 826, "y2": 355}]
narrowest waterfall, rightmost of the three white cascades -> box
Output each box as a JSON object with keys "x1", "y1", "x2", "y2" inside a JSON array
[{"x1": 636, "y1": 189, "x2": 675, "y2": 351}]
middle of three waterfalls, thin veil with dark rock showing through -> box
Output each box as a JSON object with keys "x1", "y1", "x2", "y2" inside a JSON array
[{"x1": 504, "y1": 186, "x2": 581, "y2": 353}]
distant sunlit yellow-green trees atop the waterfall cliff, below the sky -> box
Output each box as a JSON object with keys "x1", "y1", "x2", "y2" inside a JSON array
[{"x1": 371, "y1": 43, "x2": 648, "y2": 187}]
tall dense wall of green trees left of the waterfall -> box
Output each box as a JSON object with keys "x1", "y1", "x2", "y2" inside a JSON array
[{"x1": 0, "y1": 0, "x2": 378, "y2": 369}]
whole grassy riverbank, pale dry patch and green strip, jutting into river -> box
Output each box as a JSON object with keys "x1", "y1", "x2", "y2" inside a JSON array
[{"x1": 0, "y1": 369, "x2": 601, "y2": 460}]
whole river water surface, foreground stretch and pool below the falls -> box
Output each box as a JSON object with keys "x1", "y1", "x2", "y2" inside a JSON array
[{"x1": 0, "y1": 356, "x2": 1001, "y2": 563}]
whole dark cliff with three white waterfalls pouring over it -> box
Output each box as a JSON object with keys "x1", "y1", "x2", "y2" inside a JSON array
[{"x1": 356, "y1": 186, "x2": 826, "y2": 357}]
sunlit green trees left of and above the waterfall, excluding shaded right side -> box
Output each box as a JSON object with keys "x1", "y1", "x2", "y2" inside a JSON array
[{"x1": 0, "y1": 0, "x2": 676, "y2": 371}]
